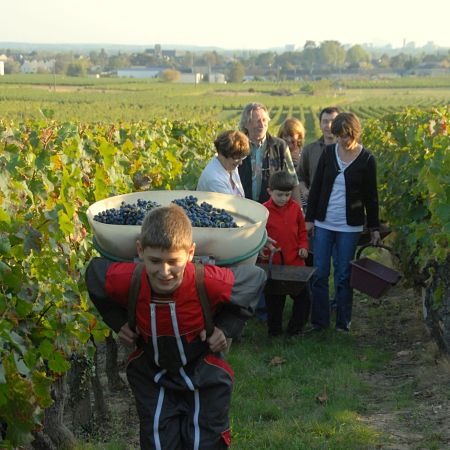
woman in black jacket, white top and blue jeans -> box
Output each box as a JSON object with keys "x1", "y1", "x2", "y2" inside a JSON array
[{"x1": 305, "y1": 113, "x2": 381, "y2": 331}]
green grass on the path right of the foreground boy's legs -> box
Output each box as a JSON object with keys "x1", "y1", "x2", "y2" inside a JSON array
[{"x1": 229, "y1": 320, "x2": 387, "y2": 450}]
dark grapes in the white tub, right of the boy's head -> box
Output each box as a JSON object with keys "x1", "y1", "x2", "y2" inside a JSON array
[{"x1": 172, "y1": 195, "x2": 237, "y2": 228}]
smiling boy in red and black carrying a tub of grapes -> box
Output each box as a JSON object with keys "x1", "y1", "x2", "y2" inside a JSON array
[{"x1": 86, "y1": 205, "x2": 266, "y2": 450}]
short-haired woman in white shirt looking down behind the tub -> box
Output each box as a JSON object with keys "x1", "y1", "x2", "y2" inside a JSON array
[{"x1": 197, "y1": 130, "x2": 250, "y2": 197}]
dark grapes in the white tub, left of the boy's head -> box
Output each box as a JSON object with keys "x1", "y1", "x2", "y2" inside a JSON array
[{"x1": 94, "y1": 199, "x2": 161, "y2": 225}]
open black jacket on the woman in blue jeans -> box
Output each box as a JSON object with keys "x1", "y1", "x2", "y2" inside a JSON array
[{"x1": 305, "y1": 144, "x2": 380, "y2": 230}]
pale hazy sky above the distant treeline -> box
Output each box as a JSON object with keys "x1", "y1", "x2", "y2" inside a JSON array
[{"x1": 5, "y1": 0, "x2": 450, "y2": 50}]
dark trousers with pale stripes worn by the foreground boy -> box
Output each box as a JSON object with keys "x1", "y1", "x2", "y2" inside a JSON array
[{"x1": 127, "y1": 355, "x2": 233, "y2": 450}]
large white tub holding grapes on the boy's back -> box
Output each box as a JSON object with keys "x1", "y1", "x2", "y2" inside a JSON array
[{"x1": 87, "y1": 190, "x2": 268, "y2": 266}]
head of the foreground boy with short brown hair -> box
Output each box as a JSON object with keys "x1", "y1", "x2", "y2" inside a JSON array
[{"x1": 136, "y1": 205, "x2": 195, "y2": 294}]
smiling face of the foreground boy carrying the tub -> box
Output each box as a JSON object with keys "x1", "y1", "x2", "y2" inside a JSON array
[{"x1": 137, "y1": 241, "x2": 195, "y2": 294}]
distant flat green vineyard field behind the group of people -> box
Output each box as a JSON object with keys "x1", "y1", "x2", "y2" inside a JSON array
[{"x1": 0, "y1": 75, "x2": 450, "y2": 135}]
